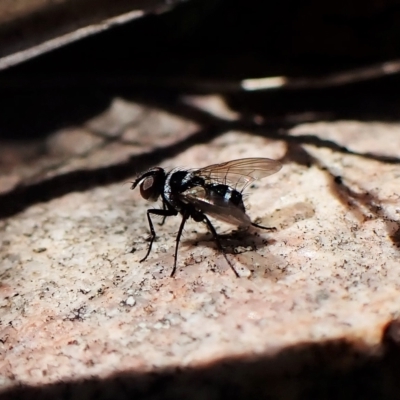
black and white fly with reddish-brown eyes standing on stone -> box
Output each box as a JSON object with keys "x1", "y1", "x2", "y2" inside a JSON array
[{"x1": 131, "y1": 158, "x2": 282, "y2": 277}]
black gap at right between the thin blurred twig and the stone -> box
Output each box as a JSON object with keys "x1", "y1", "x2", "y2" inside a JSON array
[{"x1": 228, "y1": 76, "x2": 400, "y2": 121}]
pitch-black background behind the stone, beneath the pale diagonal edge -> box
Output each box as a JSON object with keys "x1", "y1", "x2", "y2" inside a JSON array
[{"x1": 0, "y1": 0, "x2": 400, "y2": 139}]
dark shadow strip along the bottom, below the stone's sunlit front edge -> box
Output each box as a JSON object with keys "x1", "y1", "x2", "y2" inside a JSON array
[{"x1": 0, "y1": 321, "x2": 400, "y2": 400}]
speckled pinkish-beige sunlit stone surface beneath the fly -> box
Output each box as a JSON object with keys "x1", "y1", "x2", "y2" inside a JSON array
[{"x1": 0, "y1": 98, "x2": 400, "y2": 399}]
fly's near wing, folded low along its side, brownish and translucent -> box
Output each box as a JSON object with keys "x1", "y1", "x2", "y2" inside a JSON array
[{"x1": 180, "y1": 186, "x2": 251, "y2": 227}]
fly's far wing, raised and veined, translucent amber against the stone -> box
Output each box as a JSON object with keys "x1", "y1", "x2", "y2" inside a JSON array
[{"x1": 193, "y1": 158, "x2": 282, "y2": 191}]
